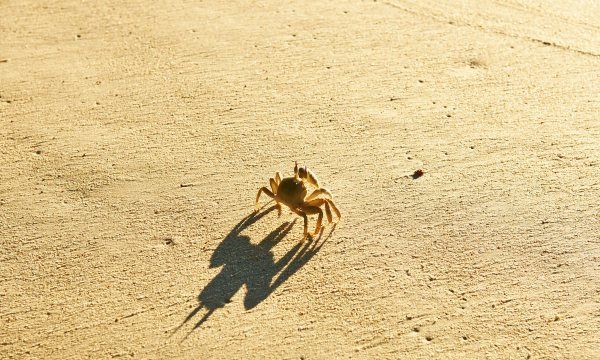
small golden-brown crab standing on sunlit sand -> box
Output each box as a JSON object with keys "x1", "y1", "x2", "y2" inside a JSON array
[{"x1": 254, "y1": 162, "x2": 342, "y2": 240}]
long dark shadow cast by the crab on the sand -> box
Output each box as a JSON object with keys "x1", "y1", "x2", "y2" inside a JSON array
[{"x1": 175, "y1": 206, "x2": 335, "y2": 337}]
